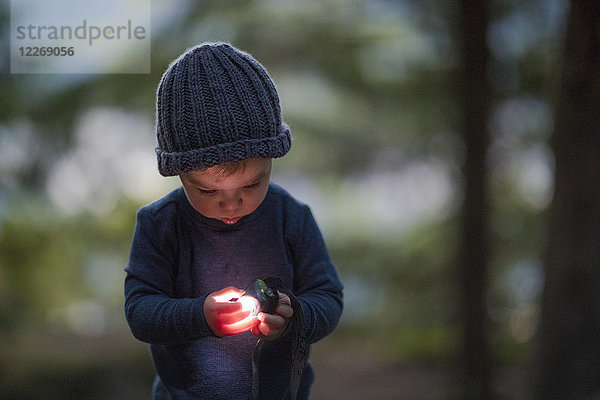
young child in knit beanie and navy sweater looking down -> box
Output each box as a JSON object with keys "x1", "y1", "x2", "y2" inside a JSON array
[{"x1": 125, "y1": 43, "x2": 343, "y2": 400}]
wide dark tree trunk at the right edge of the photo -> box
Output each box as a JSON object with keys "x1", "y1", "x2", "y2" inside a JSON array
[{"x1": 534, "y1": 1, "x2": 600, "y2": 400}]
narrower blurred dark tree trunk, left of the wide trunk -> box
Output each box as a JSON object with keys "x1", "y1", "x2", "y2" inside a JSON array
[{"x1": 460, "y1": 0, "x2": 490, "y2": 400}]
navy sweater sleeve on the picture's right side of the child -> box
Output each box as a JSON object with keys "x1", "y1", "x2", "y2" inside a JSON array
[{"x1": 290, "y1": 206, "x2": 343, "y2": 343}]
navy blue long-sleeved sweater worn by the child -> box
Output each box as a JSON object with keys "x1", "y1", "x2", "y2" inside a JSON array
[{"x1": 125, "y1": 184, "x2": 342, "y2": 400}]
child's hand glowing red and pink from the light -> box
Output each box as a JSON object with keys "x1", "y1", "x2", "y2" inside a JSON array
[{"x1": 204, "y1": 286, "x2": 258, "y2": 337}]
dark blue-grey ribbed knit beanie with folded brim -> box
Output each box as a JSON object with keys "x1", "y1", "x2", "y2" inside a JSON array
[{"x1": 156, "y1": 43, "x2": 292, "y2": 176}]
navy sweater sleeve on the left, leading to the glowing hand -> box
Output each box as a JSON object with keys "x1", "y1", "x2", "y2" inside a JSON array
[{"x1": 125, "y1": 208, "x2": 213, "y2": 344}]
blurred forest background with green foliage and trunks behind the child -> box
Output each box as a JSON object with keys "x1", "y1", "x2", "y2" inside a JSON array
[{"x1": 0, "y1": 0, "x2": 600, "y2": 400}]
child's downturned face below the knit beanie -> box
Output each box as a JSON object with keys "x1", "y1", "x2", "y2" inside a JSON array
[{"x1": 179, "y1": 158, "x2": 271, "y2": 225}]
